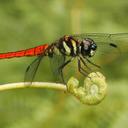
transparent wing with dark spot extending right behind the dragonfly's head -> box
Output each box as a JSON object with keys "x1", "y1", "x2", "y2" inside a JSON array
[{"x1": 73, "y1": 33, "x2": 128, "y2": 63}]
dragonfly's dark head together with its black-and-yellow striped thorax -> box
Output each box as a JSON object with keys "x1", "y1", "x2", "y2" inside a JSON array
[{"x1": 57, "y1": 36, "x2": 97, "y2": 57}]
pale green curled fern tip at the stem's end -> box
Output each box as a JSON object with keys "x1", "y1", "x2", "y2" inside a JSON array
[{"x1": 67, "y1": 72, "x2": 107, "y2": 105}]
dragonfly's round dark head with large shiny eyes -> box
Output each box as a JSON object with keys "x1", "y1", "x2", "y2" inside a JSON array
[{"x1": 80, "y1": 38, "x2": 97, "y2": 57}]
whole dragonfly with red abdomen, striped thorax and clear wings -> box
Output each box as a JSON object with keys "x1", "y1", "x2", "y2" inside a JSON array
[{"x1": 0, "y1": 33, "x2": 128, "y2": 83}]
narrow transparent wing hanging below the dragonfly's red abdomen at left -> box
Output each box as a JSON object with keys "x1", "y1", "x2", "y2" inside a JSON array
[{"x1": 24, "y1": 56, "x2": 43, "y2": 84}]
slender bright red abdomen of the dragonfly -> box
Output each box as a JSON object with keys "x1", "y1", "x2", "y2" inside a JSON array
[{"x1": 0, "y1": 44, "x2": 48, "y2": 59}]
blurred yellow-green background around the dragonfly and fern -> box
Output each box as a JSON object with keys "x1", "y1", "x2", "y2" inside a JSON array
[{"x1": 0, "y1": 0, "x2": 128, "y2": 128}]
